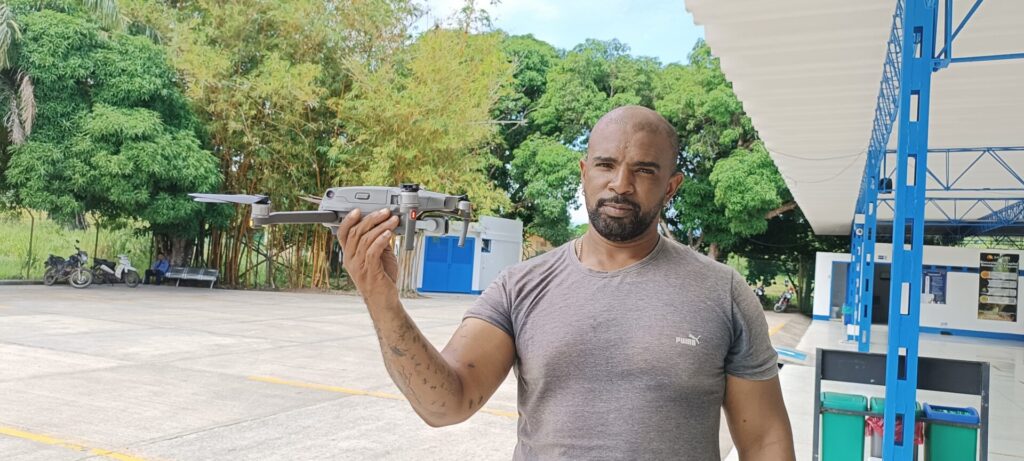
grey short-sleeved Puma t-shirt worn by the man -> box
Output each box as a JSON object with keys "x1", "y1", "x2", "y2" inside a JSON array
[{"x1": 466, "y1": 235, "x2": 778, "y2": 461}]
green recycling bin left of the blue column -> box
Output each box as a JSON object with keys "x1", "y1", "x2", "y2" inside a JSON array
[{"x1": 821, "y1": 392, "x2": 867, "y2": 461}]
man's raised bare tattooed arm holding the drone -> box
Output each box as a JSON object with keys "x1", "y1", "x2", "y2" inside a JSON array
[{"x1": 338, "y1": 209, "x2": 515, "y2": 427}]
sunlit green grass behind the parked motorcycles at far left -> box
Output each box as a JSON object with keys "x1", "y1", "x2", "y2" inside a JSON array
[{"x1": 0, "y1": 212, "x2": 151, "y2": 280}]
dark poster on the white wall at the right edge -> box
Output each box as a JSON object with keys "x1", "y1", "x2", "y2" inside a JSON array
[{"x1": 978, "y1": 253, "x2": 1020, "y2": 322}]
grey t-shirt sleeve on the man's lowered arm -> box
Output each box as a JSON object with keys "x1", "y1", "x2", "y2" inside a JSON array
[{"x1": 725, "y1": 271, "x2": 778, "y2": 381}]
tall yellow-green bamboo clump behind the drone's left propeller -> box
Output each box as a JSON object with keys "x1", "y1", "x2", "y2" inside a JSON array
[{"x1": 149, "y1": 0, "x2": 418, "y2": 287}]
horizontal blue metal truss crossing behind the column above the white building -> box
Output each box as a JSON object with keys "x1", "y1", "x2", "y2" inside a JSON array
[{"x1": 882, "y1": 146, "x2": 1024, "y2": 192}]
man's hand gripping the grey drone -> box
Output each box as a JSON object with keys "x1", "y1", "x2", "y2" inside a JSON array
[{"x1": 338, "y1": 208, "x2": 398, "y2": 303}]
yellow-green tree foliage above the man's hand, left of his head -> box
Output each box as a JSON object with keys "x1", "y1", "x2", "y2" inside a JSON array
[{"x1": 333, "y1": 25, "x2": 512, "y2": 296}]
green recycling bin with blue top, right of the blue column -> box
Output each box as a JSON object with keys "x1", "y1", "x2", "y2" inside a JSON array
[{"x1": 925, "y1": 404, "x2": 980, "y2": 461}]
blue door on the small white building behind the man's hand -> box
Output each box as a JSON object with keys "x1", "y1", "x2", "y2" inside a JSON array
[{"x1": 420, "y1": 237, "x2": 475, "y2": 293}]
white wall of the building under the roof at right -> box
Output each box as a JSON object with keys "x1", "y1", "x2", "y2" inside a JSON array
[{"x1": 814, "y1": 244, "x2": 1024, "y2": 335}]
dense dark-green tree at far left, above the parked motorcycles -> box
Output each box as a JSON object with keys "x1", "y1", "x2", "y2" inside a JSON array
[{"x1": 4, "y1": 7, "x2": 220, "y2": 259}]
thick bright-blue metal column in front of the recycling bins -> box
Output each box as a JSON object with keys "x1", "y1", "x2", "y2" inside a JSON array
[{"x1": 884, "y1": 0, "x2": 938, "y2": 461}]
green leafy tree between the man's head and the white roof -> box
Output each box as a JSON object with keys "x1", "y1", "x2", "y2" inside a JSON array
[{"x1": 654, "y1": 42, "x2": 795, "y2": 258}]
